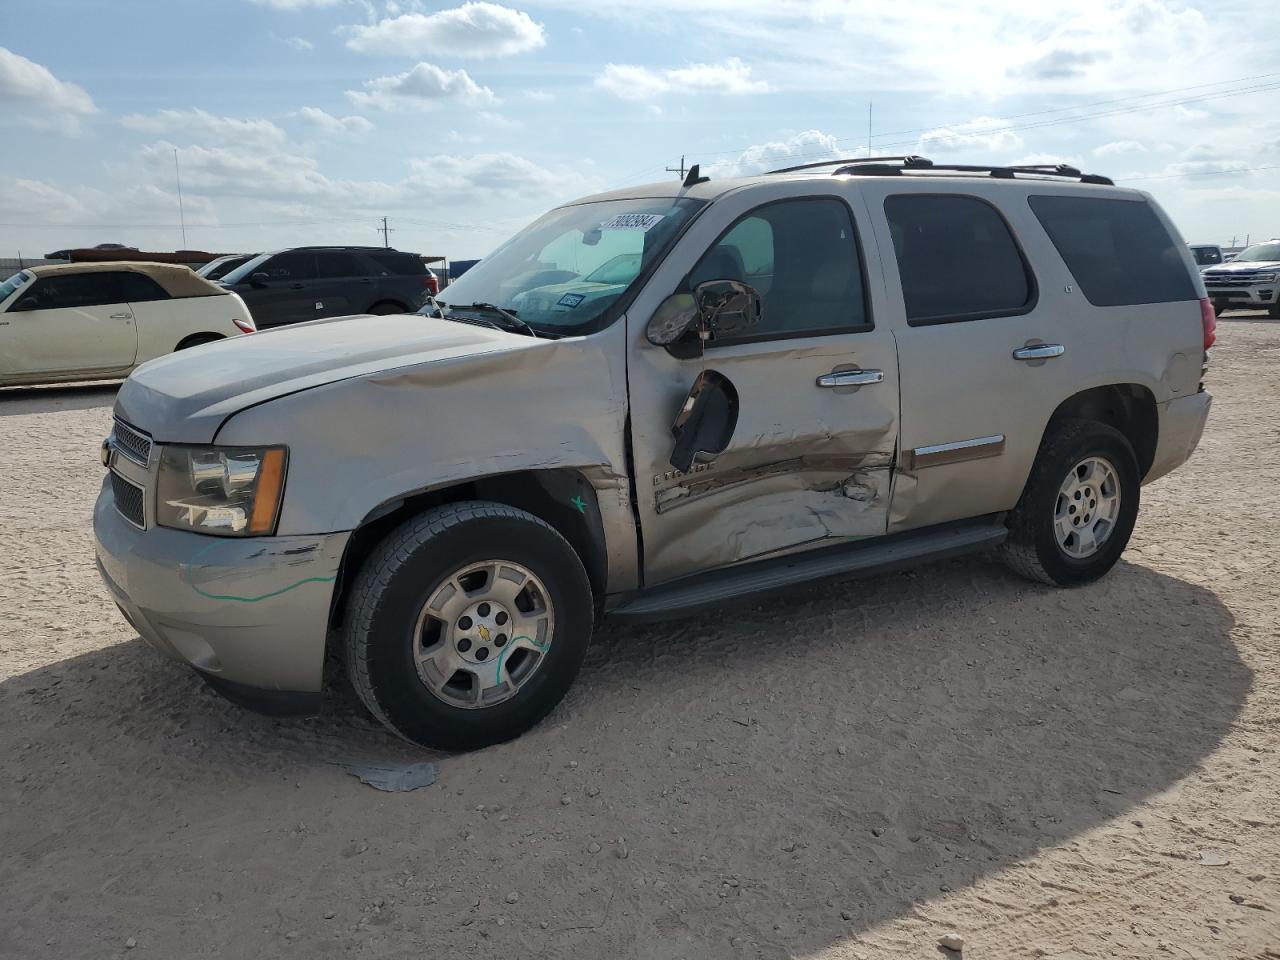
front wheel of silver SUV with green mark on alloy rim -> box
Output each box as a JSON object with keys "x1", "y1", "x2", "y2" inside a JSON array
[{"x1": 343, "y1": 502, "x2": 595, "y2": 750}]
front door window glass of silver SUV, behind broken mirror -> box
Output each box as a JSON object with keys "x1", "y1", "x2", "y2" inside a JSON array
[{"x1": 689, "y1": 198, "x2": 869, "y2": 337}]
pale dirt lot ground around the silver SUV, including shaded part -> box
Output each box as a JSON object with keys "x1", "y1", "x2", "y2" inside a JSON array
[{"x1": 0, "y1": 316, "x2": 1280, "y2": 960}]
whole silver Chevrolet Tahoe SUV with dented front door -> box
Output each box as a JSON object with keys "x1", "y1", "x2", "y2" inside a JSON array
[{"x1": 93, "y1": 157, "x2": 1213, "y2": 750}]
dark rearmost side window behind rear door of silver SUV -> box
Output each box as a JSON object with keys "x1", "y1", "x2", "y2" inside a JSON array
[{"x1": 1029, "y1": 196, "x2": 1197, "y2": 307}]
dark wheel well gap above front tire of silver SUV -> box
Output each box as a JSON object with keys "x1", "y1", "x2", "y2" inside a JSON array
[{"x1": 330, "y1": 468, "x2": 608, "y2": 626}]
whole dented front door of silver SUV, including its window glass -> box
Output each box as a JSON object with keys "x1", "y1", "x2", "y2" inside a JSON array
[{"x1": 628, "y1": 183, "x2": 899, "y2": 586}]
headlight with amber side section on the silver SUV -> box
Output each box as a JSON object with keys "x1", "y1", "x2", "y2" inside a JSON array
[{"x1": 156, "y1": 445, "x2": 288, "y2": 536}]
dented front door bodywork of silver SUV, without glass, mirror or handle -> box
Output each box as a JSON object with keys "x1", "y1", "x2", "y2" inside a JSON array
[{"x1": 627, "y1": 180, "x2": 899, "y2": 586}]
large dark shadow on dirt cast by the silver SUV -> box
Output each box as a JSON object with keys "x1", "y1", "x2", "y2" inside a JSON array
[{"x1": 0, "y1": 558, "x2": 1251, "y2": 957}]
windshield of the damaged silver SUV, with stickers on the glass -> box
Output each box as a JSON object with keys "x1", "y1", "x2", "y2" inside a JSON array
[{"x1": 426, "y1": 197, "x2": 707, "y2": 335}]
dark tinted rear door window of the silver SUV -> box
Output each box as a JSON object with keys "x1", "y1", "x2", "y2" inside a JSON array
[{"x1": 884, "y1": 193, "x2": 1036, "y2": 326}]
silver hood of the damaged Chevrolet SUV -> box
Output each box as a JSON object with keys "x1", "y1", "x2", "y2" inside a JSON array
[{"x1": 115, "y1": 314, "x2": 524, "y2": 443}]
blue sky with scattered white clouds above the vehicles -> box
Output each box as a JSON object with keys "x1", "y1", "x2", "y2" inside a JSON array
[{"x1": 0, "y1": 0, "x2": 1280, "y2": 259}]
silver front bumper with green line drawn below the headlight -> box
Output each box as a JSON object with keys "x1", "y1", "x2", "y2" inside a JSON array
[{"x1": 93, "y1": 479, "x2": 349, "y2": 713}]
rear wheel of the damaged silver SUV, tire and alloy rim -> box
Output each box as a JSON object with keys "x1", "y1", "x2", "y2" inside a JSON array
[{"x1": 1001, "y1": 420, "x2": 1142, "y2": 586}]
